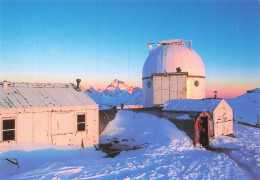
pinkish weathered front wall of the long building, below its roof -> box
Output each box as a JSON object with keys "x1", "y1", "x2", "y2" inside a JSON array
[{"x1": 0, "y1": 105, "x2": 99, "y2": 147}]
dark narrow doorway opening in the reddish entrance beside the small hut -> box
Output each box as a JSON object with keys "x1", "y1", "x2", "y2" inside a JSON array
[{"x1": 200, "y1": 116, "x2": 209, "y2": 147}]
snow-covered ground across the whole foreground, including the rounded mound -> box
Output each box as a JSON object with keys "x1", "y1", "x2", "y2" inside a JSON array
[{"x1": 0, "y1": 110, "x2": 260, "y2": 179}]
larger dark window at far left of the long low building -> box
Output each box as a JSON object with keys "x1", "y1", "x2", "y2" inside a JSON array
[{"x1": 3, "y1": 119, "x2": 15, "y2": 141}]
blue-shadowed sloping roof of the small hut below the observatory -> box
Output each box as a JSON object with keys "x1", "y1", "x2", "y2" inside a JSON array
[{"x1": 163, "y1": 99, "x2": 222, "y2": 112}]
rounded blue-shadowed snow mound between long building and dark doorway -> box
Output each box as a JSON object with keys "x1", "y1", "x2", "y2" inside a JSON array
[{"x1": 100, "y1": 110, "x2": 193, "y2": 150}]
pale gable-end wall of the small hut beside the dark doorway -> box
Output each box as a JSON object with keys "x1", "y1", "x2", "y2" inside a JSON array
[{"x1": 213, "y1": 100, "x2": 233, "y2": 137}]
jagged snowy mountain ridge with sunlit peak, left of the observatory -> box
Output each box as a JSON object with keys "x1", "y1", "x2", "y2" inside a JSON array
[{"x1": 84, "y1": 79, "x2": 142, "y2": 107}]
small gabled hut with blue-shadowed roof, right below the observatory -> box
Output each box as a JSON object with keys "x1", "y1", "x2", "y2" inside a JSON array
[{"x1": 163, "y1": 99, "x2": 233, "y2": 137}]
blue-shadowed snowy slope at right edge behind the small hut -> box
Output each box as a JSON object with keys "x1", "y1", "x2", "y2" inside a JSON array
[{"x1": 226, "y1": 88, "x2": 260, "y2": 125}]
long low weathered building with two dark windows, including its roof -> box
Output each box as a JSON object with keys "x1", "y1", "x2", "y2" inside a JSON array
[{"x1": 0, "y1": 81, "x2": 99, "y2": 147}]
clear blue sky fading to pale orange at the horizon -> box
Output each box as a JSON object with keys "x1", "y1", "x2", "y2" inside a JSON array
[{"x1": 0, "y1": 0, "x2": 260, "y2": 96}]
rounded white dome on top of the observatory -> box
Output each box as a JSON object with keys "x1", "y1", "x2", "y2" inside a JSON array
[{"x1": 143, "y1": 40, "x2": 205, "y2": 78}]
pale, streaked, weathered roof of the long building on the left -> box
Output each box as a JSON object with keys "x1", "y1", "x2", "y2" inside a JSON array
[{"x1": 0, "y1": 82, "x2": 96, "y2": 109}]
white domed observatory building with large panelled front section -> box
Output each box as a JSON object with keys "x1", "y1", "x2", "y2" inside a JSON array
[{"x1": 142, "y1": 39, "x2": 205, "y2": 107}]
